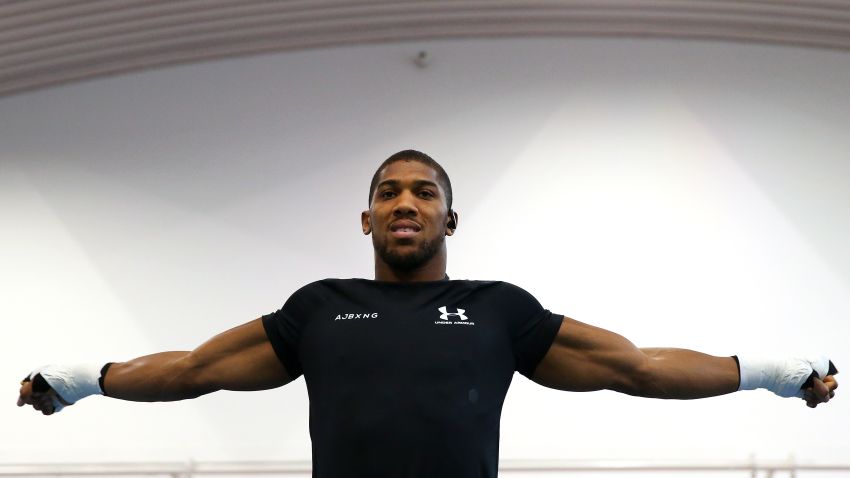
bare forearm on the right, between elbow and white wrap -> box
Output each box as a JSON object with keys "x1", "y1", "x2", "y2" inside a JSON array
[{"x1": 623, "y1": 348, "x2": 740, "y2": 400}]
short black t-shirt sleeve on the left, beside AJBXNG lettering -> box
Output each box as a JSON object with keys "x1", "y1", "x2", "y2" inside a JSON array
[{"x1": 262, "y1": 285, "x2": 310, "y2": 379}]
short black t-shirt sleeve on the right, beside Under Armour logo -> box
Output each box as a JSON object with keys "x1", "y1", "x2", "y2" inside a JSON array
[{"x1": 496, "y1": 284, "x2": 564, "y2": 378}]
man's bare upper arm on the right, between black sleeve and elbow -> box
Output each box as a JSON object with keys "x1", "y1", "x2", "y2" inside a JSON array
[{"x1": 532, "y1": 317, "x2": 649, "y2": 394}]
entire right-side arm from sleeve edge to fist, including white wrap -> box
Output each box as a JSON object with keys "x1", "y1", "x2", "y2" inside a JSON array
[{"x1": 533, "y1": 317, "x2": 838, "y2": 407}]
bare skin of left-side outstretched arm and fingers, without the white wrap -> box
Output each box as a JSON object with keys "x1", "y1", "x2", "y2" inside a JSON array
[{"x1": 18, "y1": 319, "x2": 291, "y2": 414}]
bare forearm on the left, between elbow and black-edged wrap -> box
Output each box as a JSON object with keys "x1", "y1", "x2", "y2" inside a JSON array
[{"x1": 103, "y1": 351, "x2": 216, "y2": 402}]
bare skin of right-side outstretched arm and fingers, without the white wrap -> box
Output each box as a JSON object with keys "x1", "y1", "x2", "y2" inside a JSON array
[{"x1": 533, "y1": 318, "x2": 837, "y2": 406}]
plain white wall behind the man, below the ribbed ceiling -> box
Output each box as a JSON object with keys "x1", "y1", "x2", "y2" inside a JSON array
[{"x1": 0, "y1": 39, "x2": 850, "y2": 462}]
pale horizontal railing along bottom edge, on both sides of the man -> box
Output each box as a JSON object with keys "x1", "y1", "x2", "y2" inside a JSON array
[{"x1": 0, "y1": 459, "x2": 850, "y2": 478}]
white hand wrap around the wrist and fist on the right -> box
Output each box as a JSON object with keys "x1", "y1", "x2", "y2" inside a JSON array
[{"x1": 738, "y1": 355, "x2": 829, "y2": 398}]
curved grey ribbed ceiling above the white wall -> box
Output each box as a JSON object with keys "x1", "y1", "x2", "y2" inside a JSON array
[{"x1": 0, "y1": 0, "x2": 850, "y2": 95}]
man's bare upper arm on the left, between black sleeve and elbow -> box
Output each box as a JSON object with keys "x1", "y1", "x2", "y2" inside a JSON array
[{"x1": 187, "y1": 319, "x2": 292, "y2": 391}]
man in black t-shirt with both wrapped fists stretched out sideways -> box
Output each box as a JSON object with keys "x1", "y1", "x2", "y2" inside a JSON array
[{"x1": 18, "y1": 151, "x2": 837, "y2": 477}]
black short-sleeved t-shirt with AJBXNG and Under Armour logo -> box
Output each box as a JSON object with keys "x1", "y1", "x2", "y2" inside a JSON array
[{"x1": 263, "y1": 279, "x2": 562, "y2": 478}]
